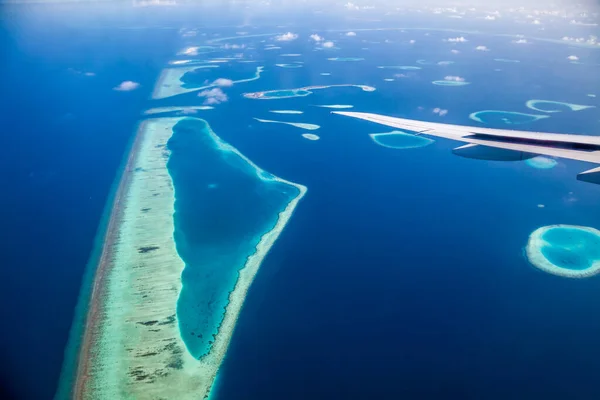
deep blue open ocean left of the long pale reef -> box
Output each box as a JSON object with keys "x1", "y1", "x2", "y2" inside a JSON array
[{"x1": 0, "y1": 4, "x2": 176, "y2": 399}]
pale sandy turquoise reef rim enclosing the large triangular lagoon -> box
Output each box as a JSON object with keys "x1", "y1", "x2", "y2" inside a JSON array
[{"x1": 68, "y1": 118, "x2": 306, "y2": 400}]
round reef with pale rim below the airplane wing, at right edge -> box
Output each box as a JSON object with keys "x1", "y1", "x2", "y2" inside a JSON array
[{"x1": 526, "y1": 225, "x2": 600, "y2": 278}]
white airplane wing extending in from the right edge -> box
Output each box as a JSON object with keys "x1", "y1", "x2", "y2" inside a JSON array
[{"x1": 332, "y1": 111, "x2": 600, "y2": 184}]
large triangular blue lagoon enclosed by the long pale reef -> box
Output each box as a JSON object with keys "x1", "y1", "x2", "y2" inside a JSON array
[{"x1": 167, "y1": 118, "x2": 298, "y2": 358}]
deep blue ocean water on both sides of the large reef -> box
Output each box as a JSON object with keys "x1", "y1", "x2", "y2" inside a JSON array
[{"x1": 0, "y1": 3, "x2": 600, "y2": 399}]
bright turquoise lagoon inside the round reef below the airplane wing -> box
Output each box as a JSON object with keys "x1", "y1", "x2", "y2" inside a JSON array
[{"x1": 541, "y1": 226, "x2": 600, "y2": 270}]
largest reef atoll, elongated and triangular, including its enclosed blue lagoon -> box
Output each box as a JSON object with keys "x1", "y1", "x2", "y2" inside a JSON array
[{"x1": 57, "y1": 117, "x2": 306, "y2": 400}]
